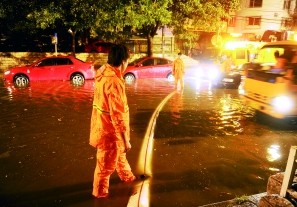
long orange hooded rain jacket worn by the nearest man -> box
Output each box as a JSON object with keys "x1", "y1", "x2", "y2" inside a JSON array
[{"x1": 90, "y1": 64, "x2": 130, "y2": 149}]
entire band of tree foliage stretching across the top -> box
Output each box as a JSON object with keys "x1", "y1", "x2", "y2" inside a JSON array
[{"x1": 0, "y1": 0, "x2": 239, "y2": 55}]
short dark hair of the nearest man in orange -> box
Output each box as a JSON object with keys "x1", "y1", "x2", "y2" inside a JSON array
[{"x1": 107, "y1": 44, "x2": 130, "y2": 67}]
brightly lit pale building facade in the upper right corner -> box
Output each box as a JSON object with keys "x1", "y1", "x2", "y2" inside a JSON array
[{"x1": 227, "y1": 0, "x2": 297, "y2": 41}]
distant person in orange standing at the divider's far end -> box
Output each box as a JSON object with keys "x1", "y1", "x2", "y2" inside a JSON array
[{"x1": 172, "y1": 52, "x2": 185, "y2": 90}]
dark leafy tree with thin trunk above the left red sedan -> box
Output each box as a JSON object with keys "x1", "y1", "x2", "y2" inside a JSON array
[{"x1": 27, "y1": 0, "x2": 99, "y2": 54}]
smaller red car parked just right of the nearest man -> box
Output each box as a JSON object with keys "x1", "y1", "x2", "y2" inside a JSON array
[{"x1": 123, "y1": 57, "x2": 174, "y2": 82}]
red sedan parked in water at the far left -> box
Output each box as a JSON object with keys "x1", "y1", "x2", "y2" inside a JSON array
[{"x1": 3, "y1": 56, "x2": 94, "y2": 87}]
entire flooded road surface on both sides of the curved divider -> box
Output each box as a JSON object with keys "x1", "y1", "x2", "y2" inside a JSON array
[{"x1": 0, "y1": 80, "x2": 297, "y2": 206}]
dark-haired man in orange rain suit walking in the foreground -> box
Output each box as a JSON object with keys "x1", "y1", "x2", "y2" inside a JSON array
[{"x1": 90, "y1": 45, "x2": 136, "y2": 198}]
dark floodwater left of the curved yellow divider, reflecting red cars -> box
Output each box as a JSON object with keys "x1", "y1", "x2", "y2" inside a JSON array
[{"x1": 0, "y1": 78, "x2": 172, "y2": 206}]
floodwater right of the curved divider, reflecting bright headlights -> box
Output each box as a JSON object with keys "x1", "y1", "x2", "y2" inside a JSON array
[{"x1": 152, "y1": 79, "x2": 297, "y2": 207}]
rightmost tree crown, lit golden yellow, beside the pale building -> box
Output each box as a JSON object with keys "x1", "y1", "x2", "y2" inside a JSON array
[{"x1": 169, "y1": 0, "x2": 240, "y2": 52}]
